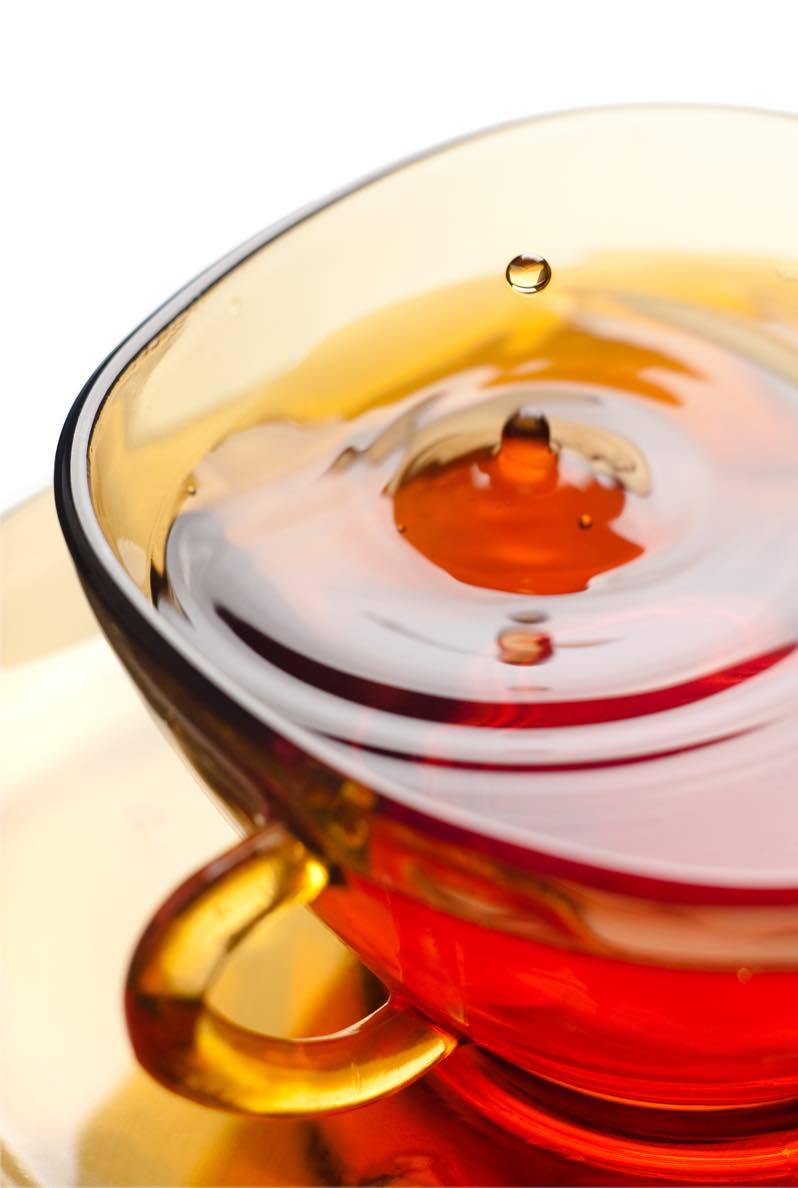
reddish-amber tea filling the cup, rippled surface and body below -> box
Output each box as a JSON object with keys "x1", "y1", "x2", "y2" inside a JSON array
[{"x1": 157, "y1": 259, "x2": 798, "y2": 1131}]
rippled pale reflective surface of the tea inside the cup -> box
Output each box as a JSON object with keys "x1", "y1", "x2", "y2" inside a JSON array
[{"x1": 159, "y1": 261, "x2": 798, "y2": 885}]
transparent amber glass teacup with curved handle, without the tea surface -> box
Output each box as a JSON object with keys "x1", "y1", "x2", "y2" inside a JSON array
[{"x1": 56, "y1": 107, "x2": 798, "y2": 1181}]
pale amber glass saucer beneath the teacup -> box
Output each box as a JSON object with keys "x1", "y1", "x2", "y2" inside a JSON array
[{"x1": 0, "y1": 492, "x2": 627, "y2": 1188}]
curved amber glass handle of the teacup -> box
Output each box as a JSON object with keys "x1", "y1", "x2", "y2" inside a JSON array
[{"x1": 126, "y1": 827, "x2": 456, "y2": 1116}]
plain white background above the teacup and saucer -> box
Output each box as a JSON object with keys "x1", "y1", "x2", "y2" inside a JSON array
[{"x1": 0, "y1": 0, "x2": 798, "y2": 508}]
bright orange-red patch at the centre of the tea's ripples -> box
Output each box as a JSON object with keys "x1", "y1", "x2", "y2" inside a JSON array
[{"x1": 393, "y1": 435, "x2": 642, "y2": 594}]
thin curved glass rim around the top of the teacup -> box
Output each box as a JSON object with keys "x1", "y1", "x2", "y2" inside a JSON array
[{"x1": 55, "y1": 103, "x2": 798, "y2": 901}]
